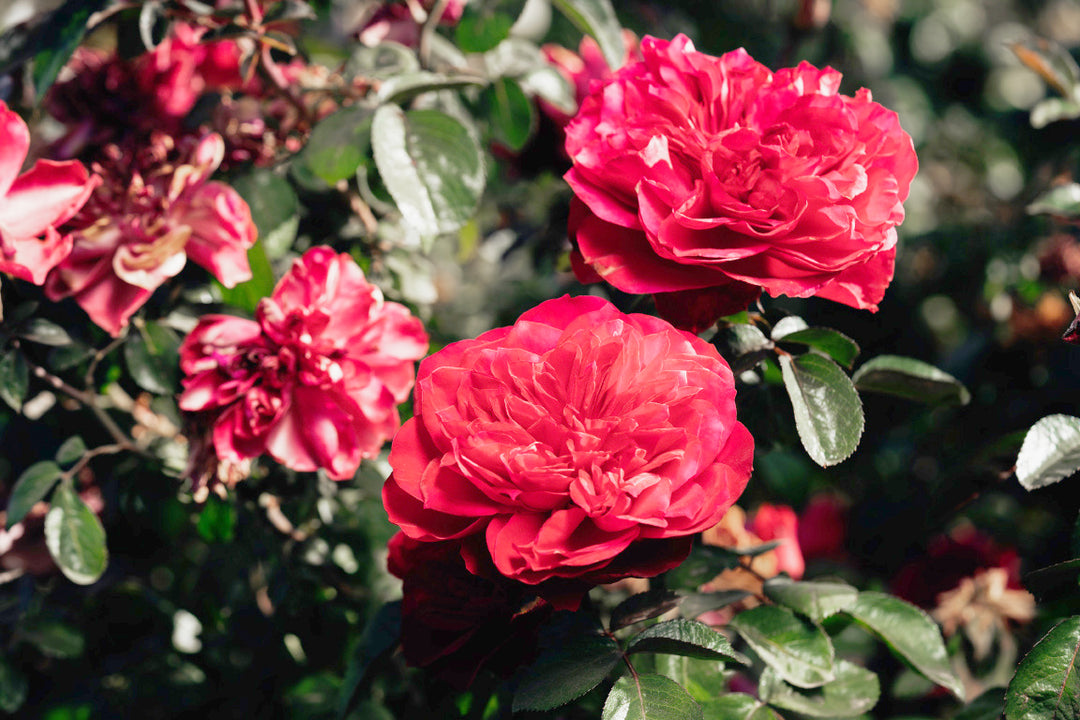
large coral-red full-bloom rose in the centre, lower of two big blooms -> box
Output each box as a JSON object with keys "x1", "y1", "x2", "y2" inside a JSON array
[{"x1": 382, "y1": 297, "x2": 754, "y2": 603}]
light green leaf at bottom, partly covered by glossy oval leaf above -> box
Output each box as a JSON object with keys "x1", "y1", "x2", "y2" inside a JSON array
[{"x1": 758, "y1": 660, "x2": 881, "y2": 718}]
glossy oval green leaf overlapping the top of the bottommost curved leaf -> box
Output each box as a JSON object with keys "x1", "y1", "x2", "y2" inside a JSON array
[{"x1": 729, "y1": 606, "x2": 836, "y2": 688}]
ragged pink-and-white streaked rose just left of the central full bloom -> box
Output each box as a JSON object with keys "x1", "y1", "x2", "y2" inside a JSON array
[{"x1": 180, "y1": 247, "x2": 428, "y2": 479}]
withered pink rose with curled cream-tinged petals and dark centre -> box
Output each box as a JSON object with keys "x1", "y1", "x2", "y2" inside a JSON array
[{"x1": 45, "y1": 134, "x2": 256, "y2": 336}]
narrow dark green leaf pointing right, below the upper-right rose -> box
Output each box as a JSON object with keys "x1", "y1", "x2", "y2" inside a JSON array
[{"x1": 851, "y1": 355, "x2": 971, "y2": 405}]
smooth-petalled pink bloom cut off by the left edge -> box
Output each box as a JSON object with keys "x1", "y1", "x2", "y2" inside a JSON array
[{"x1": 0, "y1": 100, "x2": 99, "y2": 285}]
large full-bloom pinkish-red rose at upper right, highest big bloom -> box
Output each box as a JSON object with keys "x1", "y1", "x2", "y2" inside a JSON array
[{"x1": 566, "y1": 36, "x2": 918, "y2": 325}]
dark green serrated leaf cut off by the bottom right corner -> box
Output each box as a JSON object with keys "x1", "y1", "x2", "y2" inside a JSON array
[{"x1": 1004, "y1": 615, "x2": 1080, "y2": 720}]
